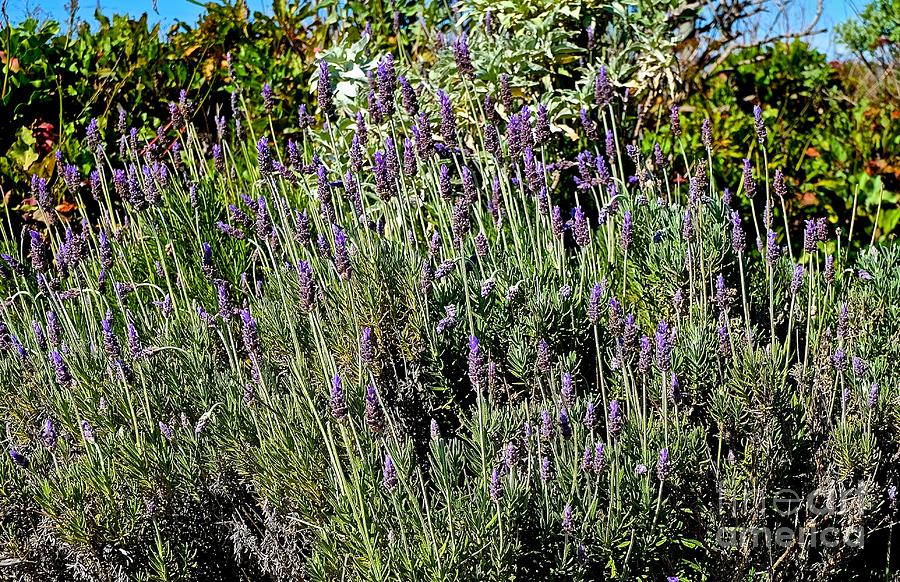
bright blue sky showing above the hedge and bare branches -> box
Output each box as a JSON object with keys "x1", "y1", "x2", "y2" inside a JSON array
[{"x1": 7, "y1": 0, "x2": 867, "y2": 55}]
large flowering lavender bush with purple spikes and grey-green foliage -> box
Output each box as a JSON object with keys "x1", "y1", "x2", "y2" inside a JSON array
[{"x1": 0, "y1": 16, "x2": 900, "y2": 580}]
